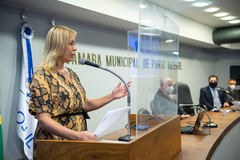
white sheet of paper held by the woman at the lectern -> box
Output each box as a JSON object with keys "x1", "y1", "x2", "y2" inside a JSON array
[{"x1": 92, "y1": 107, "x2": 130, "y2": 136}]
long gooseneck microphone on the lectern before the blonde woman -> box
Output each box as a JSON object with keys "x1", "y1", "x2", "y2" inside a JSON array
[{"x1": 79, "y1": 58, "x2": 136, "y2": 142}]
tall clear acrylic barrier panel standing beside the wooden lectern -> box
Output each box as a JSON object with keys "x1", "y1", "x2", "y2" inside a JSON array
[{"x1": 128, "y1": 0, "x2": 179, "y2": 138}]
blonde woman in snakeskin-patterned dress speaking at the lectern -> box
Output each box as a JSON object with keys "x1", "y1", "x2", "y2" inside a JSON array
[{"x1": 29, "y1": 26, "x2": 131, "y2": 158}]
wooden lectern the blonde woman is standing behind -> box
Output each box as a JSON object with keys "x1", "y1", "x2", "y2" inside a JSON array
[{"x1": 37, "y1": 114, "x2": 181, "y2": 160}]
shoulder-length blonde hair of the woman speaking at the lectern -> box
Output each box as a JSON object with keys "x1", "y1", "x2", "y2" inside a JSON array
[{"x1": 39, "y1": 26, "x2": 77, "y2": 70}]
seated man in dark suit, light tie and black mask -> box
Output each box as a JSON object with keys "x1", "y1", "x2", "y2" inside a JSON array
[{"x1": 199, "y1": 75, "x2": 229, "y2": 110}]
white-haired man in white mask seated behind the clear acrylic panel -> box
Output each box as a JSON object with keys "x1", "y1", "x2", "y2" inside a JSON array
[{"x1": 151, "y1": 77, "x2": 190, "y2": 119}]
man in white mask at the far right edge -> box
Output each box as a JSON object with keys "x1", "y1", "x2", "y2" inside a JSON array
[{"x1": 226, "y1": 79, "x2": 240, "y2": 105}]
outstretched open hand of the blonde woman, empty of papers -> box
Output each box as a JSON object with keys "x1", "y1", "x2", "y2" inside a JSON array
[{"x1": 112, "y1": 81, "x2": 131, "y2": 99}]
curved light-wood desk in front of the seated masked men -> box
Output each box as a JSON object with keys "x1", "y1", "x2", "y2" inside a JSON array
[{"x1": 174, "y1": 107, "x2": 240, "y2": 160}]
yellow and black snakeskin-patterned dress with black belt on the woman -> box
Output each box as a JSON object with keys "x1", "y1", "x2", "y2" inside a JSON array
[{"x1": 29, "y1": 68, "x2": 87, "y2": 158}]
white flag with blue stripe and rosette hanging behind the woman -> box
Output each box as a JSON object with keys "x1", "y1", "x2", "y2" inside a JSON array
[{"x1": 17, "y1": 23, "x2": 37, "y2": 159}]
